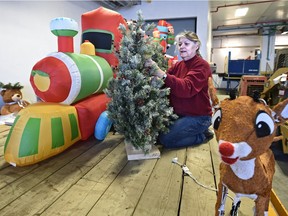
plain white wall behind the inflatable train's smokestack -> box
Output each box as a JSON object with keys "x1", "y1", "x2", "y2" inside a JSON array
[{"x1": 0, "y1": 1, "x2": 98, "y2": 102}]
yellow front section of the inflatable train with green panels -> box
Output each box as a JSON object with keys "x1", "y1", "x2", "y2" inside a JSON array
[{"x1": 4, "y1": 102, "x2": 81, "y2": 166}]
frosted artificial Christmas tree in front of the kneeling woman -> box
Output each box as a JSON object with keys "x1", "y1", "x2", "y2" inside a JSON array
[{"x1": 105, "y1": 11, "x2": 177, "y2": 153}]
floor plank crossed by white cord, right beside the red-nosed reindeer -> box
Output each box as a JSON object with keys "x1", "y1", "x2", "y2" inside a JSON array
[{"x1": 180, "y1": 140, "x2": 216, "y2": 215}]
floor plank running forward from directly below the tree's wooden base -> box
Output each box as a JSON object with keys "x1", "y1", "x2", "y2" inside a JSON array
[{"x1": 88, "y1": 150, "x2": 159, "y2": 216}]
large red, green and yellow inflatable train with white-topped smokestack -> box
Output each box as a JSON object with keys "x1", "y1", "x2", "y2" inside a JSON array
[{"x1": 4, "y1": 7, "x2": 126, "y2": 166}]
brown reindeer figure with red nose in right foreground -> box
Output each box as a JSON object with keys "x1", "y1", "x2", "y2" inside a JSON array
[{"x1": 212, "y1": 93, "x2": 288, "y2": 216}]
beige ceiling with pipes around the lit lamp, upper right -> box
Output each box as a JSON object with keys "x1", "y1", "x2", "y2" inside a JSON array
[{"x1": 210, "y1": 0, "x2": 288, "y2": 37}]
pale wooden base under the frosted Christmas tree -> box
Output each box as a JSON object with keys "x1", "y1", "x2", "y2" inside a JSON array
[{"x1": 124, "y1": 140, "x2": 160, "y2": 160}]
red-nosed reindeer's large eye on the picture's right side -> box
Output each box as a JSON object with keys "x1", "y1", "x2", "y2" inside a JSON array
[{"x1": 255, "y1": 111, "x2": 275, "y2": 137}]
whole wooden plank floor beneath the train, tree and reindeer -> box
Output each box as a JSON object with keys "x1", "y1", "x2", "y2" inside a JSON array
[{"x1": 0, "y1": 125, "x2": 288, "y2": 216}]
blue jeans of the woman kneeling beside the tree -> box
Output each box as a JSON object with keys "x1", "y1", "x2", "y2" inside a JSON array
[{"x1": 159, "y1": 116, "x2": 211, "y2": 148}]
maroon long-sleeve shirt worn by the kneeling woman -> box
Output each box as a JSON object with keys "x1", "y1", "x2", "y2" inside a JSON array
[{"x1": 165, "y1": 55, "x2": 212, "y2": 116}]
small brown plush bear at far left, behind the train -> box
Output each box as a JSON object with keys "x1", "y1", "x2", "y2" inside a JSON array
[{"x1": 0, "y1": 82, "x2": 30, "y2": 115}]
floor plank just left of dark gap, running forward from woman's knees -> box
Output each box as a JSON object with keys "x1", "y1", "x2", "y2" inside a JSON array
[{"x1": 133, "y1": 149, "x2": 186, "y2": 216}]
